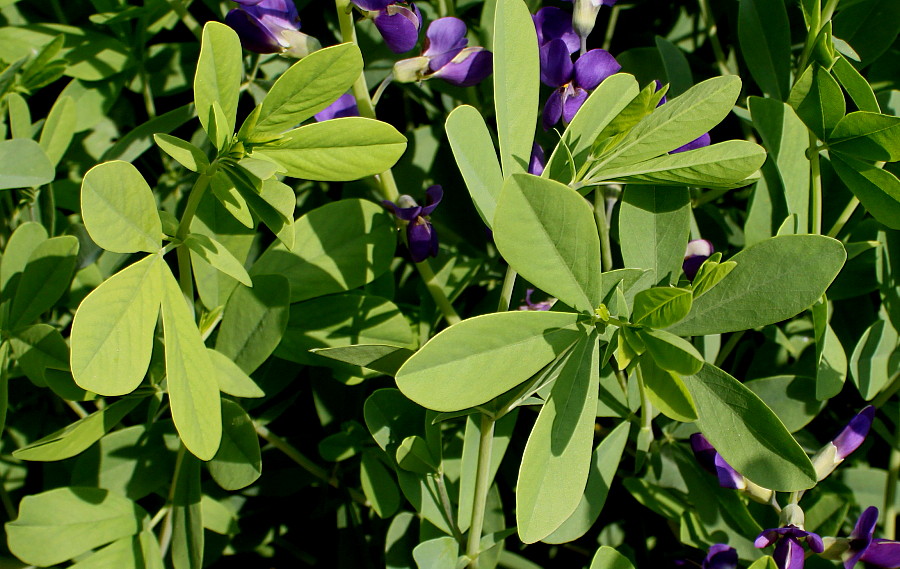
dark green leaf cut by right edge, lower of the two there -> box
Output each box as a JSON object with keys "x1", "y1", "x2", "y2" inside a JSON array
[{"x1": 831, "y1": 153, "x2": 900, "y2": 229}]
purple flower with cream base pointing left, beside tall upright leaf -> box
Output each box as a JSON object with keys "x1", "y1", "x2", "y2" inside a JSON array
[{"x1": 393, "y1": 17, "x2": 493, "y2": 87}]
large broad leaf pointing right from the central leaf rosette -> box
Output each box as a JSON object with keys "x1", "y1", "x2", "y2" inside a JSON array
[{"x1": 669, "y1": 235, "x2": 846, "y2": 336}]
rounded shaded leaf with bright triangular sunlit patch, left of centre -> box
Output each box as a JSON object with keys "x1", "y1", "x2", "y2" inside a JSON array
[{"x1": 250, "y1": 197, "x2": 397, "y2": 302}]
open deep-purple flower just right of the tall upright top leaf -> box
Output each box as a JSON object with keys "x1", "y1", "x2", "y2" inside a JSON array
[{"x1": 541, "y1": 43, "x2": 622, "y2": 130}]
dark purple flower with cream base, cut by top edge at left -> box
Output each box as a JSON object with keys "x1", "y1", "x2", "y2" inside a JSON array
[{"x1": 225, "y1": 0, "x2": 322, "y2": 58}]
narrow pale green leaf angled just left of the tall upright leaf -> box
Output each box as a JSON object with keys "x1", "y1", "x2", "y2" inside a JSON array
[{"x1": 445, "y1": 105, "x2": 503, "y2": 228}]
